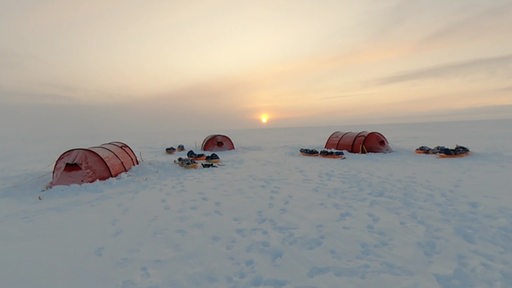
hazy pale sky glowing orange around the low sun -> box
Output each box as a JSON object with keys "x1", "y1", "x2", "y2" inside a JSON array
[{"x1": 0, "y1": 0, "x2": 512, "y2": 128}]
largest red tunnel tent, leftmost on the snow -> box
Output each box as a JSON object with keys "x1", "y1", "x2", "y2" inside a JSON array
[{"x1": 49, "y1": 142, "x2": 139, "y2": 187}]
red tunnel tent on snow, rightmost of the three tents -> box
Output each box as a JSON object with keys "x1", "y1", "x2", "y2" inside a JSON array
[{"x1": 325, "y1": 131, "x2": 392, "y2": 154}]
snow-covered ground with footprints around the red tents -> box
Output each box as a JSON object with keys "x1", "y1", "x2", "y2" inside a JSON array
[{"x1": 0, "y1": 119, "x2": 512, "y2": 288}]
